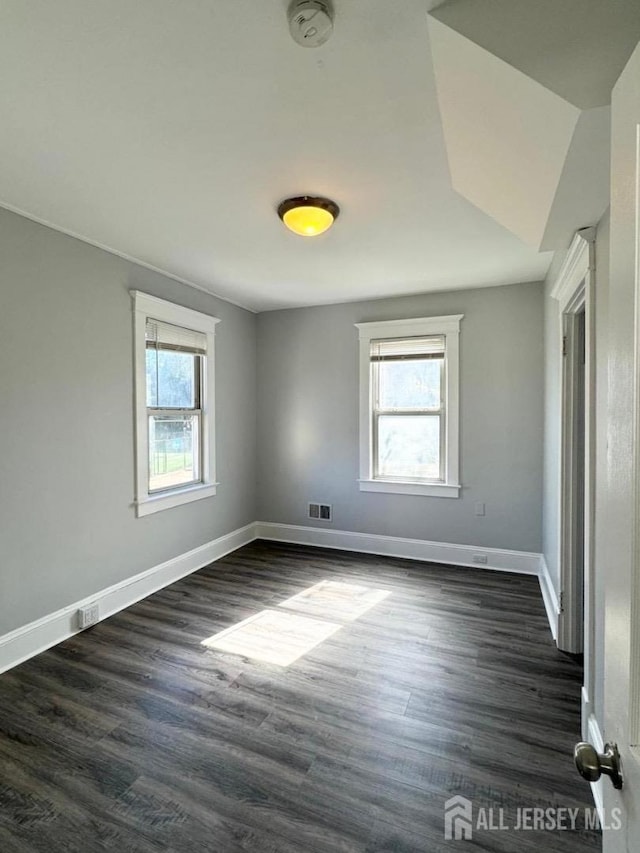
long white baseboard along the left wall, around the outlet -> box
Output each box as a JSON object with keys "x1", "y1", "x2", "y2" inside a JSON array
[{"x1": 0, "y1": 524, "x2": 256, "y2": 672}]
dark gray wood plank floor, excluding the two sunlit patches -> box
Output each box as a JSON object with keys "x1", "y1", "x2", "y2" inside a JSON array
[{"x1": 0, "y1": 542, "x2": 601, "y2": 853}]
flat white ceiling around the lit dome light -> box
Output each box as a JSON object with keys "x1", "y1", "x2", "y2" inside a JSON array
[{"x1": 0, "y1": 0, "x2": 550, "y2": 310}]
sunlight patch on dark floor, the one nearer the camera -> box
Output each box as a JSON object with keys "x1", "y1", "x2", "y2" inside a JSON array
[{"x1": 202, "y1": 610, "x2": 342, "y2": 666}]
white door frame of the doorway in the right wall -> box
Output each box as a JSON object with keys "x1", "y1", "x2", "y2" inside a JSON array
[{"x1": 551, "y1": 227, "x2": 596, "y2": 726}]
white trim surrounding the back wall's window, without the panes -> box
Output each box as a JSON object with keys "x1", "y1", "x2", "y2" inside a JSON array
[{"x1": 355, "y1": 314, "x2": 464, "y2": 498}]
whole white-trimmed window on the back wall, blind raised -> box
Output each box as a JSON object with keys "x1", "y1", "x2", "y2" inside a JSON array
[{"x1": 356, "y1": 314, "x2": 462, "y2": 498}]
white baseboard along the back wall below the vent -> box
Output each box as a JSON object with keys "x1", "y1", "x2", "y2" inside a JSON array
[{"x1": 256, "y1": 521, "x2": 540, "y2": 576}]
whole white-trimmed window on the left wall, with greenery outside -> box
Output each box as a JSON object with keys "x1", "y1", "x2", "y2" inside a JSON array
[{"x1": 132, "y1": 291, "x2": 219, "y2": 516}]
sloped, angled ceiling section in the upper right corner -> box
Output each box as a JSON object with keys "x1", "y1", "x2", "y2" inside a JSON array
[{"x1": 430, "y1": 0, "x2": 640, "y2": 250}]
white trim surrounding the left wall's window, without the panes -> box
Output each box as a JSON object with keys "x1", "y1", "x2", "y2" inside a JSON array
[{"x1": 131, "y1": 290, "x2": 220, "y2": 517}]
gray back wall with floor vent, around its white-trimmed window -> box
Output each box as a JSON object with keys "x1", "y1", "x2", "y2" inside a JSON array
[{"x1": 258, "y1": 283, "x2": 543, "y2": 552}]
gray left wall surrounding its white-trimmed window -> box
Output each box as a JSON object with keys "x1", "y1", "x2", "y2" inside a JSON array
[{"x1": 0, "y1": 210, "x2": 256, "y2": 635}]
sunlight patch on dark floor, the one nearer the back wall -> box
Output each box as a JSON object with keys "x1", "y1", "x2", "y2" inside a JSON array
[{"x1": 278, "y1": 581, "x2": 391, "y2": 622}]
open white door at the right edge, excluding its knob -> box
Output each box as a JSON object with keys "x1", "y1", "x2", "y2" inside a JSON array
[{"x1": 598, "y1": 35, "x2": 640, "y2": 853}]
